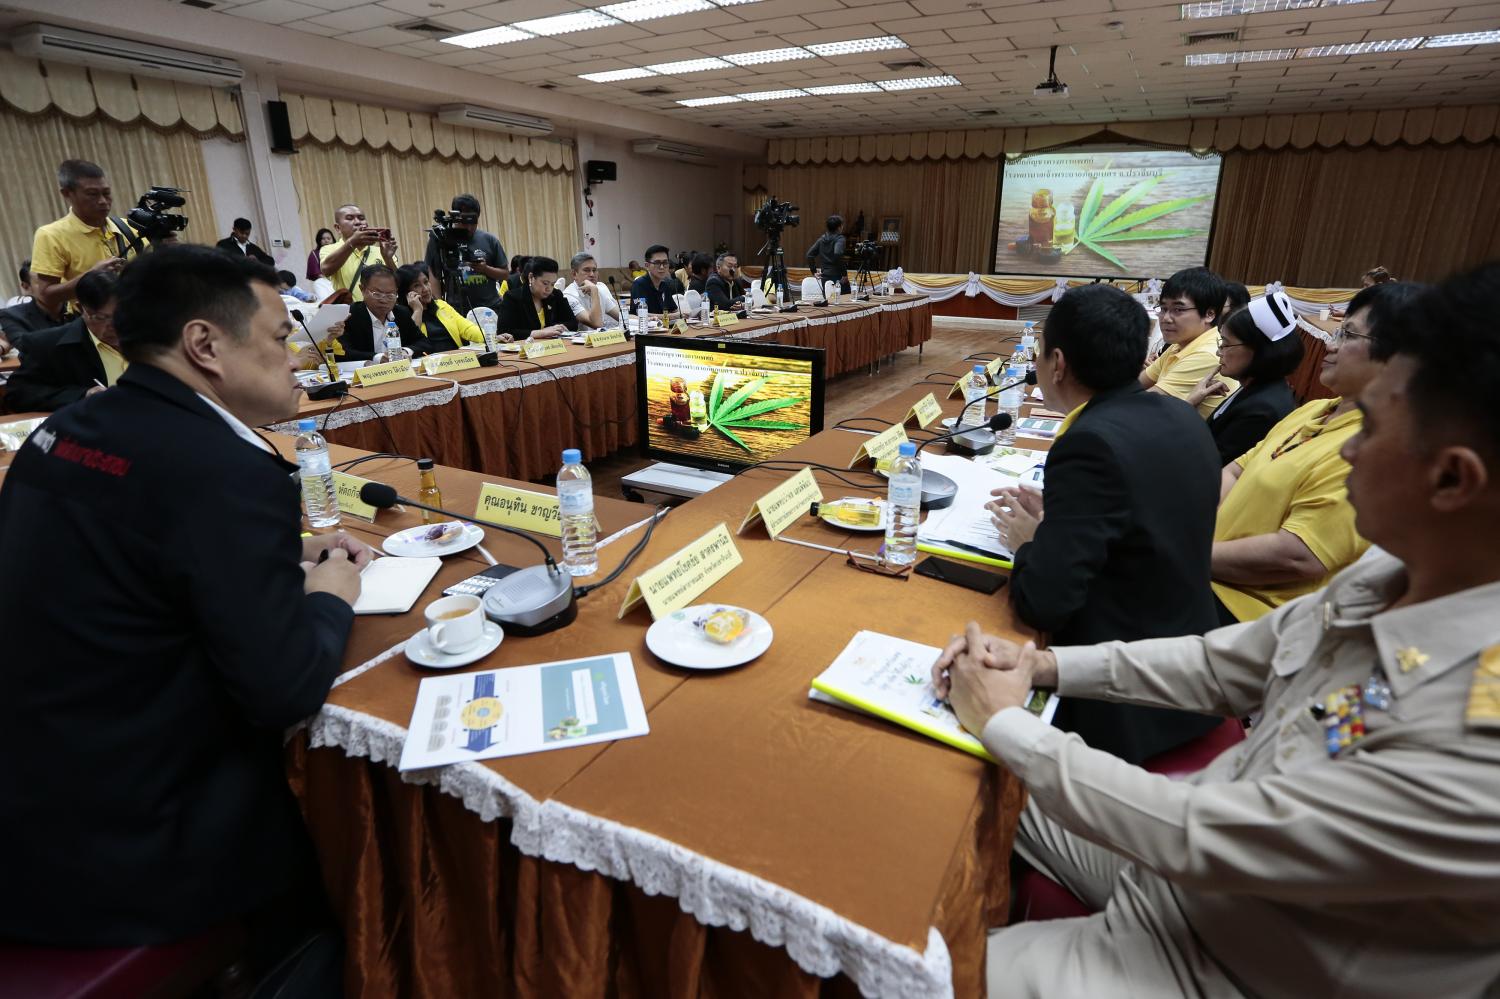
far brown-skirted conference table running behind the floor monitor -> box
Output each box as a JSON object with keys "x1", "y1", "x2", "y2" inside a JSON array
[{"x1": 270, "y1": 296, "x2": 932, "y2": 479}]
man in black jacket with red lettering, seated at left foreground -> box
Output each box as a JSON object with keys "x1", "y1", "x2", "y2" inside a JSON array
[{"x1": 0, "y1": 246, "x2": 371, "y2": 996}]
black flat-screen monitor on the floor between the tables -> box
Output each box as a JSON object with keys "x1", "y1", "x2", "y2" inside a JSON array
[{"x1": 636, "y1": 335, "x2": 824, "y2": 471}]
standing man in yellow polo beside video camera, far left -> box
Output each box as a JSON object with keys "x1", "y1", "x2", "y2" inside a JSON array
[{"x1": 32, "y1": 159, "x2": 140, "y2": 315}]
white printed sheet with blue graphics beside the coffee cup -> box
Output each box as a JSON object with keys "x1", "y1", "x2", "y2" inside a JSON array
[{"x1": 401, "y1": 653, "x2": 651, "y2": 770}]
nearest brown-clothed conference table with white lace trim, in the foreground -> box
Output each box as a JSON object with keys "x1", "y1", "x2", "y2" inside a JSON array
[{"x1": 281, "y1": 373, "x2": 1046, "y2": 996}]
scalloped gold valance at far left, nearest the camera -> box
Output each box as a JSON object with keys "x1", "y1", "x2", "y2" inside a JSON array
[{"x1": 0, "y1": 51, "x2": 245, "y2": 135}]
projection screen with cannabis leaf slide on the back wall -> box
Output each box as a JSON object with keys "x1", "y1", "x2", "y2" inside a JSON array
[{"x1": 995, "y1": 150, "x2": 1221, "y2": 279}]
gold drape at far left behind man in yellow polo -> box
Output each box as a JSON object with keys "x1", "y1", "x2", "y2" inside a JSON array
[{"x1": 0, "y1": 105, "x2": 222, "y2": 297}]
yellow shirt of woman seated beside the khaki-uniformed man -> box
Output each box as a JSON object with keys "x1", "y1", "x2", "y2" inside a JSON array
[{"x1": 1214, "y1": 399, "x2": 1370, "y2": 621}]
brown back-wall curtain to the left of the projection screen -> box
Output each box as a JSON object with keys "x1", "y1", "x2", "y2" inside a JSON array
[{"x1": 767, "y1": 159, "x2": 1001, "y2": 273}]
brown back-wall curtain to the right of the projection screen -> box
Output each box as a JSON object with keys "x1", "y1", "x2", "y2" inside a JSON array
[{"x1": 1209, "y1": 143, "x2": 1500, "y2": 288}]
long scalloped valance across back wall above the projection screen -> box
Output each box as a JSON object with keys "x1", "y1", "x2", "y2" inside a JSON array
[{"x1": 767, "y1": 105, "x2": 1500, "y2": 167}]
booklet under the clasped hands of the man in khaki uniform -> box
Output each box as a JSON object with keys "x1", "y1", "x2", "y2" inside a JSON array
[{"x1": 807, "y1": 632, "x2": 1058, "y2": 762}]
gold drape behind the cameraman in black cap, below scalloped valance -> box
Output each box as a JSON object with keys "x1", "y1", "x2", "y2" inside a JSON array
[{"x1": 291, "y1": 143, "x2": 579, "y2": 270}]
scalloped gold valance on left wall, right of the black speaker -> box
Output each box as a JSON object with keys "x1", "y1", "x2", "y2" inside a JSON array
[{"x1": 282, "y1": 93, "x2": 575, "y2": 173}]
